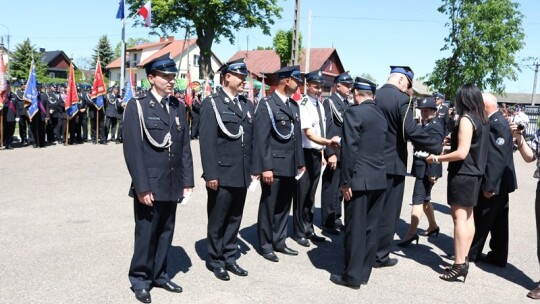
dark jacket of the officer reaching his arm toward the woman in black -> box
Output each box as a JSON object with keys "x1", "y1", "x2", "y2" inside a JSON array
[{"x1": 375, "y1": 83, "x2": 442, "y2": 176}]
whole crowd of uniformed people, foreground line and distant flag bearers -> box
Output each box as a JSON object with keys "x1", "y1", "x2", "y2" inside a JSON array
[{"x1": 3, "y1": 54, "x2": 540, "y2": 303}]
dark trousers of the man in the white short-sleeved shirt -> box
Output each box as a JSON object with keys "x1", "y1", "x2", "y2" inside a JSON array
[{"x1": 293, "y1": 149, "x2": 322, "y2": 238}]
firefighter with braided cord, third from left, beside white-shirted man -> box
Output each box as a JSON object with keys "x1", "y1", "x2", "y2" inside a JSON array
[{"x1": 253, "y1": 66, "x2": 305, "y2": 262}]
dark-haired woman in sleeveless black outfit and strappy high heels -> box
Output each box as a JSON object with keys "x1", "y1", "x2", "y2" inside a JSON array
[{"x1": 427, "y1": 84, "x2": 489, "y2": 282}]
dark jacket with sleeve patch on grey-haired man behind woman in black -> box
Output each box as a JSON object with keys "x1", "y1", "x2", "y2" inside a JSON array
[{"x1": 482, "y1": 111, "x2": 517, "y2": 194}]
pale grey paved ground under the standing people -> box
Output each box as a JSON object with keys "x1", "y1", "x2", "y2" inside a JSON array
[{"x1": 0, "y1": 141, "x2": 540, "y2": 303}]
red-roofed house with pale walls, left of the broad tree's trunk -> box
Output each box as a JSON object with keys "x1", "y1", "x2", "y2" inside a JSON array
[{"x1": 106, "y1": 36, "x2": 223, "y2": 86}]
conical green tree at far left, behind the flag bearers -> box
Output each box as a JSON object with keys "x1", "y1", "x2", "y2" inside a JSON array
[{"x1": 10, "y1": 38, "x2": 47, "y2": 82}]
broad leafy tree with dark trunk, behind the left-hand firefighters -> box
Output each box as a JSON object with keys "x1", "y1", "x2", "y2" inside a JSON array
[{"x1": 126, "y1": 0, "x2": 281, "y2": 78}]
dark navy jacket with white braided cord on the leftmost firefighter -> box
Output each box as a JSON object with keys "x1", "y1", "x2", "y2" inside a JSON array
[{"x1": 122, "y1": 94, "x2": 195, "y2": 202}]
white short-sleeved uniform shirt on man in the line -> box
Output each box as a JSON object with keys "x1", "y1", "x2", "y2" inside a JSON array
[{"x1": 299, "y1": 95, "x2": 326, "y2": 150}]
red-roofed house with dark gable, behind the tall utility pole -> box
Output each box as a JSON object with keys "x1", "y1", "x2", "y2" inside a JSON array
[{"x1": 228, "y1": 48, "x2": 345, "y2": 95}]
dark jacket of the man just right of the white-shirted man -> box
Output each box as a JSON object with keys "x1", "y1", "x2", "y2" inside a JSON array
[{"x1": 323, "y1": 93, "x2": 349, "y2": 160}]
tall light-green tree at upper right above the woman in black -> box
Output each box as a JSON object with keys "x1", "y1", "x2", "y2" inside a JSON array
[{"x1": 424, "y1": 0, "x2": 525, "y2": 100}]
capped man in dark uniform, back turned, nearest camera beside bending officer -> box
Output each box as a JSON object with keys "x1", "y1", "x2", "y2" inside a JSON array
[{"x1": 330, "y1": 77, "x2": 387, "y2": 289}]
